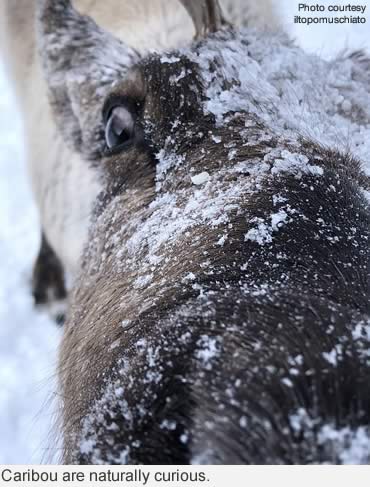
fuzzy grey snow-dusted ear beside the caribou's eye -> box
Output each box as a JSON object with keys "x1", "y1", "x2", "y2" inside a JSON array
[{"x1": 37, "y1": 0, "x2": 138, "y2": 159}]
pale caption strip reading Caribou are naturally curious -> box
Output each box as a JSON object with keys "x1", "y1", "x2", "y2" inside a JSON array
[{"x1": 0, "y1": 465, "x2": 370, "y2": 487}]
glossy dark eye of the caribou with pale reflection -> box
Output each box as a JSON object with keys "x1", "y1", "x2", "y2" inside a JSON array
[{"x1": 105, "y1": 106, "x2": 135, "y2": 149}]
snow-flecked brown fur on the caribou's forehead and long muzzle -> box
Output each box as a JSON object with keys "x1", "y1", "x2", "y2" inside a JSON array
[{"x1": 55, "y1": 36, "x2": 370, "y2": 464}]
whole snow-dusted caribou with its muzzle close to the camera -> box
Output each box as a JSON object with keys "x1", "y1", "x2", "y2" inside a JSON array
[{"x1": 3, "y1": 0, "x2": 370, "y2": 465}]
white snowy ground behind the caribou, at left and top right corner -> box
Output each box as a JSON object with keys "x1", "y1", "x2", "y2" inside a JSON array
[{"x1": 0, "y1": 0, "x2": 370, "y2": 464}]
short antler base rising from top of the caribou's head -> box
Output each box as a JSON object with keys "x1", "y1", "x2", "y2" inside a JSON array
[{"x1": 180, "y1": 0, "x2": 228, "y2": 39}]
